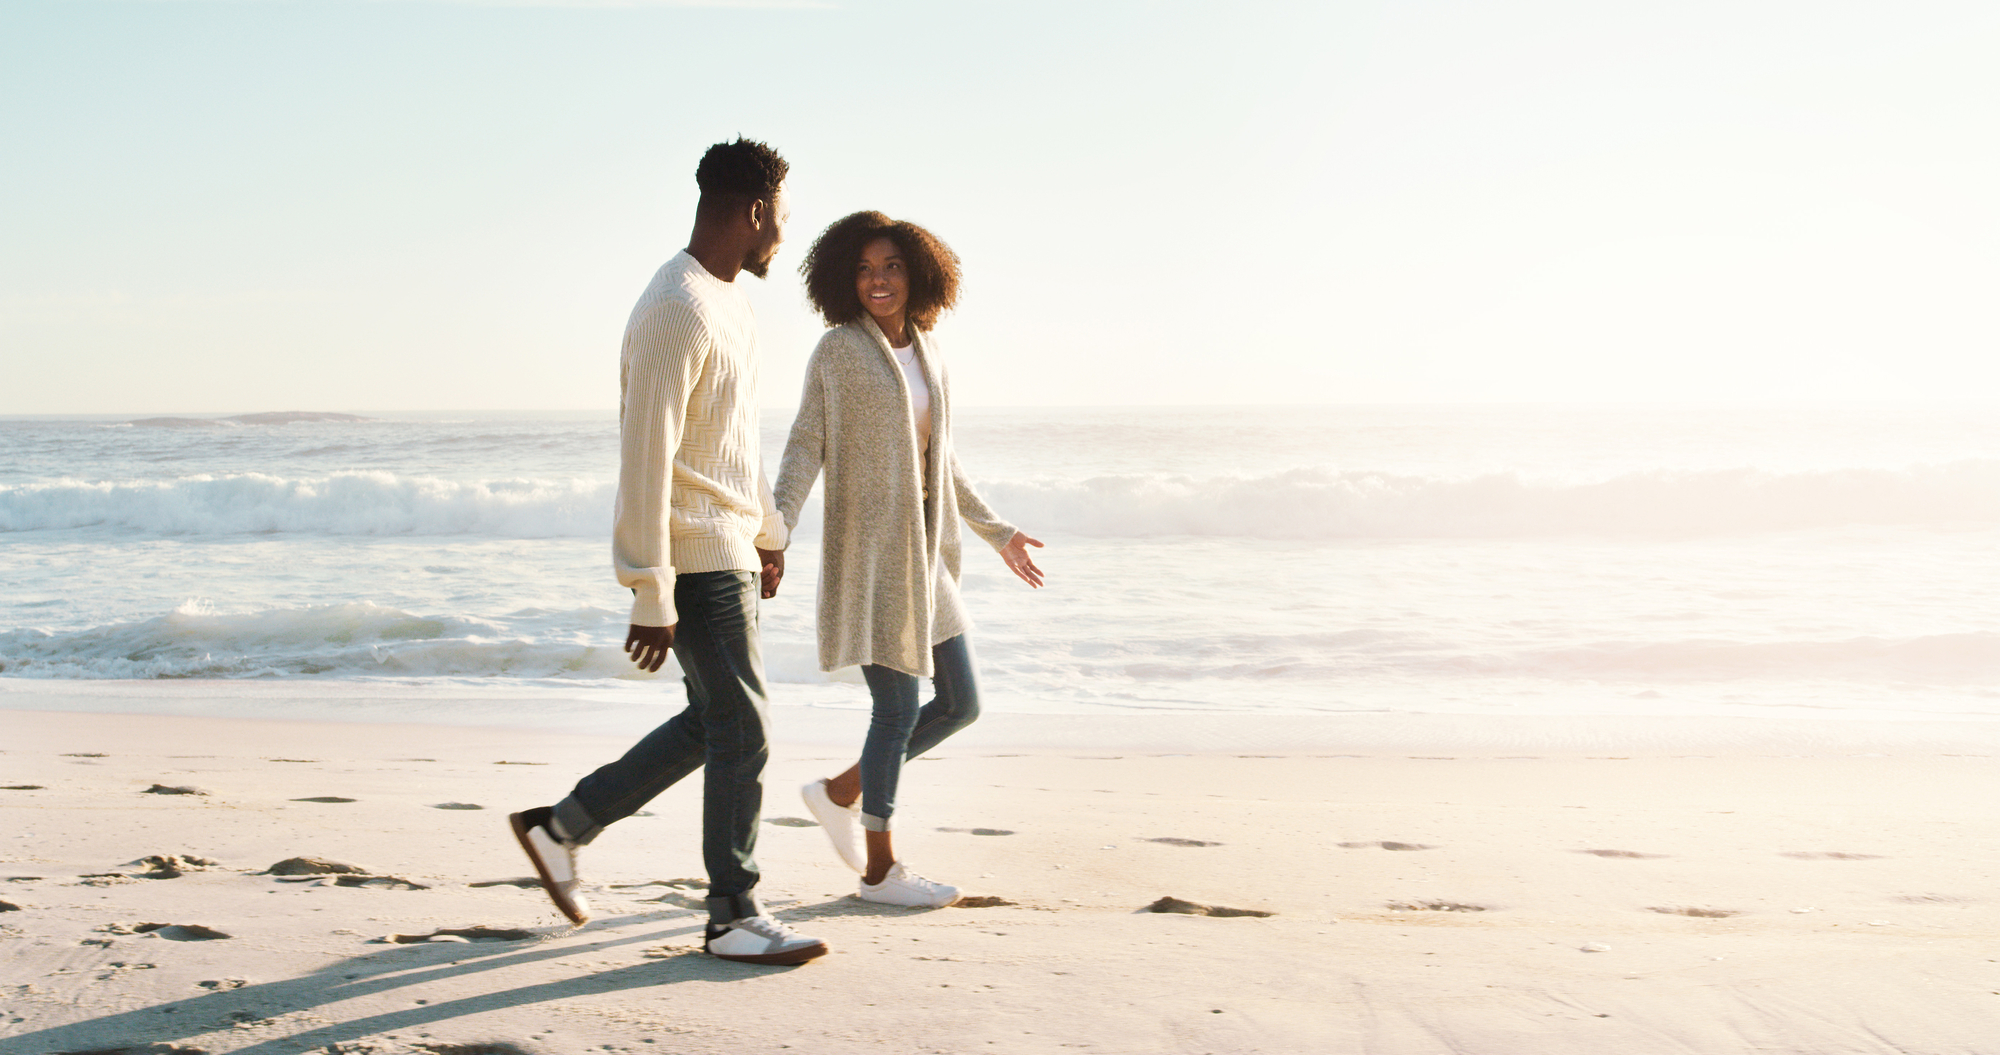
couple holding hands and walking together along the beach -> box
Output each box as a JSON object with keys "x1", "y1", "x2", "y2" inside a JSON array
[{"x1": 510, "y1": 138, "x2": 1042, "y2": 963}]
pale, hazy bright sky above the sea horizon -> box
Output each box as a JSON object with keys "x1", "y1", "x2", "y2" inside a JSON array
[{"x1": 0, "y1": 0, "x2": 2000, "y2": 414}]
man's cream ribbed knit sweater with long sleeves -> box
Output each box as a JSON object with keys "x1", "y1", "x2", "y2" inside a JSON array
[{"x1": 612, "y1": 250, "x2": 786, "y2": 625}]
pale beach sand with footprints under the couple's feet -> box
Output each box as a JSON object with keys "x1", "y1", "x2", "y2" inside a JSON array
[{"x1": 0, "y1": 711, "x2": 2000, "y2": 1055}]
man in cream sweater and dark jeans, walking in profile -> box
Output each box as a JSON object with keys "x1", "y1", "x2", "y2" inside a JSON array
[{"x1": 510, "y1": 138, "x2": 826, "y2": 963}]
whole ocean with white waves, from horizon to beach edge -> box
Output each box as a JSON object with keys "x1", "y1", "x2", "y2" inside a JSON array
[{"x1": 0, "y1": 406, "x2": 2000, "y2": 719}]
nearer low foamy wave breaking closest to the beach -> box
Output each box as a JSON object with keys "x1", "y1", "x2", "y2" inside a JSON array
[{"x1": 0, "y1": 601, "x2": 2000, "y2": 695}]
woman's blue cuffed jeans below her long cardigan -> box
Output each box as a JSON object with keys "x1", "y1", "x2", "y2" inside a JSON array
[{"x1": 862, "y1": 633, "x2": 980, "y2": 831}]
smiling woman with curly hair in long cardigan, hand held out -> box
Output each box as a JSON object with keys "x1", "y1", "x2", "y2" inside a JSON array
[{"x1": 776, "y1": 212, "x2": 1042, "y2": 905}]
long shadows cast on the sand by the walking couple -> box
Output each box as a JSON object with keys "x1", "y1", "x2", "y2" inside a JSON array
[{"x1": 0, "y1": 909, "x2": 828, "y2": 1055}]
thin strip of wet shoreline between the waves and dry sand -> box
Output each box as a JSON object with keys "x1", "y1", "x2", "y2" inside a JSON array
[{"x1": 11, "y1": 677, "x2": 2000, "y2": 753}]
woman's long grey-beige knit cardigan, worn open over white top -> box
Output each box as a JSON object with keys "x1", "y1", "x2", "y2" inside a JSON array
[{"x1": 776, "y1": 318, "x2": 1014, "y2": 677}]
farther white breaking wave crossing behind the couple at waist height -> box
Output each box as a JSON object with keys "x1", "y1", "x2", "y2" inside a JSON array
[{"x1": 0, "y1": 460, "x2": 2000, "y2": 539}]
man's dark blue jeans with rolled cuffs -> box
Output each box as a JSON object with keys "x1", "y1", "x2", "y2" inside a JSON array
[{"x1": 556, "y1": 571, "x2": 770, "y2": 923}]
